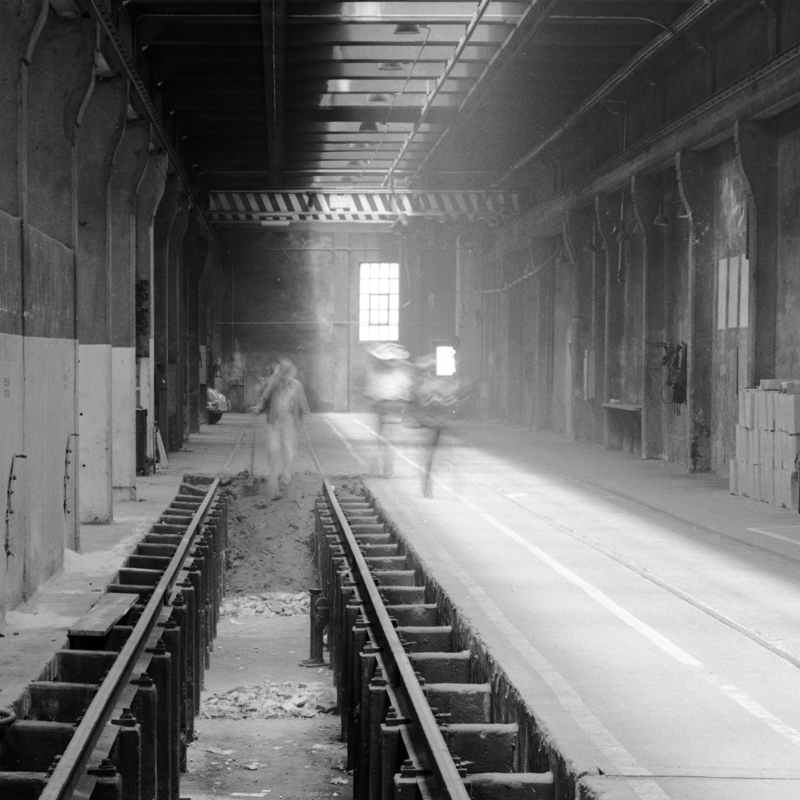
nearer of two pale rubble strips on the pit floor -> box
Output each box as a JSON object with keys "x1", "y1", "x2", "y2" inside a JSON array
[{"x1": 200, "y1": 681, "x2": 336, "y2": 719}]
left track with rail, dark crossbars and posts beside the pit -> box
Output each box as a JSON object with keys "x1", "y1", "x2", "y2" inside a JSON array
[{"x1": 0, "y1": 479, "x2": 227, "y2": 800}]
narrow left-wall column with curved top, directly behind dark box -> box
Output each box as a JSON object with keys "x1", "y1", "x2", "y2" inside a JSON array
[{"x1": 134, "y1": 153, "x2": 167, "y2": 464}]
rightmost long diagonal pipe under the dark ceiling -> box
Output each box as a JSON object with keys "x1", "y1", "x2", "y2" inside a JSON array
[{"x1": 494, "y1": 0, "x2": 724, "y2": 186}]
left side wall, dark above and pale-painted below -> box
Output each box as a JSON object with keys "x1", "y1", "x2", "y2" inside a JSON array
[{"x1": 0, "y1": 2, "x2": 220, "y2": 619}]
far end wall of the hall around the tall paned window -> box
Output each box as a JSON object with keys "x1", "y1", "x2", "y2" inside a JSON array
[{"x1": 219, "y1": 225, "x2": 455, "y2": 412}]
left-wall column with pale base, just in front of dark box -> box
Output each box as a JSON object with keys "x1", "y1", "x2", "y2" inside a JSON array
[{"x1": 110, "y1": 119, "x2": 150, "y2": 500}]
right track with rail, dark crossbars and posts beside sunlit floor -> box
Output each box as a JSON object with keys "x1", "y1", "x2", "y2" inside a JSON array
[{"x1": 315, "y1": 480, "x2": 556, "y2": 800}]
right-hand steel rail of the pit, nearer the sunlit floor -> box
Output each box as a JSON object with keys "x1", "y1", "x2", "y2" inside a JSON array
[{"x1": 323, "y1": 478, "x2": 469, "y2": 800}]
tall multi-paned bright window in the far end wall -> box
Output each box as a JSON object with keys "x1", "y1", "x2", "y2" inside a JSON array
[{"x1": 358, "y1": 263, "x2": 400, "y2": 342}]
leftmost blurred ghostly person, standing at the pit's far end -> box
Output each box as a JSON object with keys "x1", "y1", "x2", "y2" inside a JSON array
[{"x1": 251, "y1": 358, "x2": 310, "y2": 496}]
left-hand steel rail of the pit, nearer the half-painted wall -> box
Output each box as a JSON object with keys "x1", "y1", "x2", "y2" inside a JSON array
[{"x1": 39, "y1": 478, "x2": 220, "y2": 800}]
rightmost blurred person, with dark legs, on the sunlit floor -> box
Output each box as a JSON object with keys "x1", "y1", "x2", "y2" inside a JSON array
[{"x1": 412, "y1": 354, "x2": 460, "y2": 497}]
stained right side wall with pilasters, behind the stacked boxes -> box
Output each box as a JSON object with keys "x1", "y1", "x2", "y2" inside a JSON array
[{"x1": 460, "y1": 112, "x2": 800, "y2": 475}]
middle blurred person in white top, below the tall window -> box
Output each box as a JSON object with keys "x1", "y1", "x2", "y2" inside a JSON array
[{"x1": 364, "y1": 342, "x2": 413, "y2": 478}]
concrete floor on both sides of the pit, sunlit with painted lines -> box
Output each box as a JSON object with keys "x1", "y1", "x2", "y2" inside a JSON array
[{"x1": 0, "y1": 414, "x2": 800, "y2": 800}]
